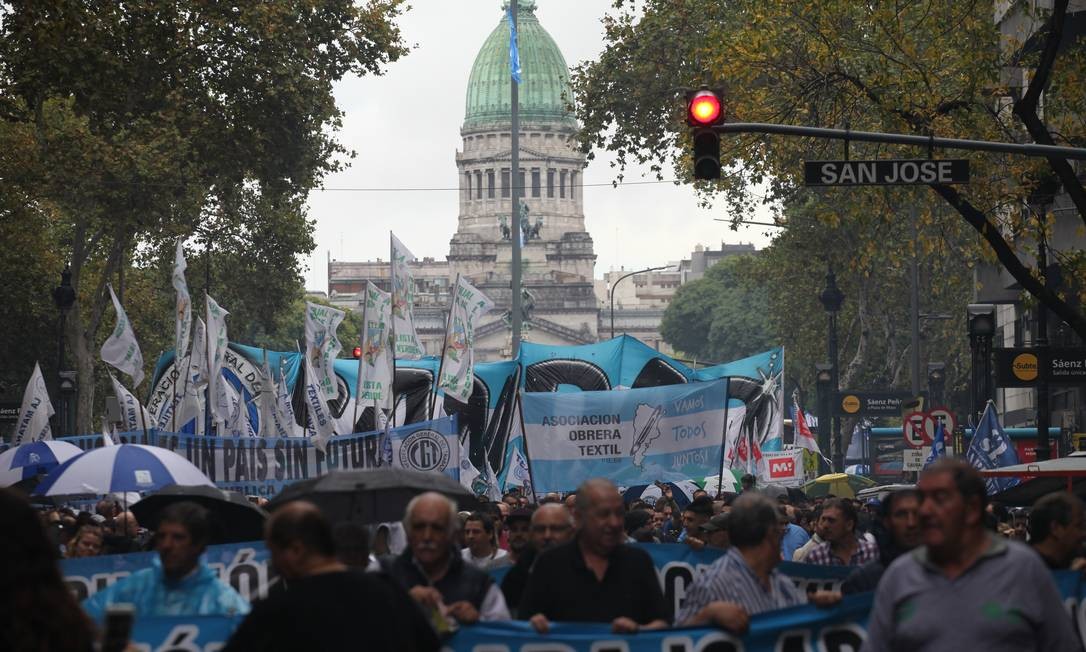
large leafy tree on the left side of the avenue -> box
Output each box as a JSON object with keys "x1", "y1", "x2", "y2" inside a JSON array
[{"x1": 0, "y1": 0, "x2": 407, "y2": 431}]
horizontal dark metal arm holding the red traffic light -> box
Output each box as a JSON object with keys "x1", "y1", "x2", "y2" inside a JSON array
[{"x1": 706, "y1": 123, "x2": 1086, "y2": 161}]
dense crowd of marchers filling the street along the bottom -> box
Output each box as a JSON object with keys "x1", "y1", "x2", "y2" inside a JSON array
[{"x1": 6, "y1": 461, "x2": 1086, "y2": 651}]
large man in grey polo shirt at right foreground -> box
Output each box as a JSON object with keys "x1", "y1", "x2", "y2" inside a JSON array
[{"x1": 862, "y1": 460, "x2": 1082, "y2": 652}]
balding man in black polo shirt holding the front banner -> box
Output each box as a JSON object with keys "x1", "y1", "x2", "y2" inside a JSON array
[{"x1": 518, "y1": 478, "x2": 668, "y2": 634}]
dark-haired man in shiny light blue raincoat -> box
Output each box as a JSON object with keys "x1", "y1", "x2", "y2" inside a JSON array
[{"x1": 83, "y1": 502, "x2": 249, "y2": 622}]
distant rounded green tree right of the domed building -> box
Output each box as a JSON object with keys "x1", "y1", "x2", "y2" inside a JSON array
[{"x1": 660, "y1": 255, "x2": 779, "y2": 362}]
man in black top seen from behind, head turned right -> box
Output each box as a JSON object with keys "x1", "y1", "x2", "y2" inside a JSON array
[{"x1": 224, "y1": 501, "x2": 440, "y2": 652}]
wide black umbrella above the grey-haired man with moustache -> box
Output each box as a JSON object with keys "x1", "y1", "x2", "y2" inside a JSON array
[{"x1": 268, "y1": 468, "x2": 479, "y2": 525}]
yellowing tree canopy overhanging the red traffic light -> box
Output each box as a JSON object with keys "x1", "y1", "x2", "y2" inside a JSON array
[{"x1": 573, "y1": 0, "x2": 1086, "y2": 338}]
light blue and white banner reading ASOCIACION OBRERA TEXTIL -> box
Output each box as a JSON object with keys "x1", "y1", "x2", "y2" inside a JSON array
[{"x1": 521, "y1": 380, "x2": 728, "y2": 493}]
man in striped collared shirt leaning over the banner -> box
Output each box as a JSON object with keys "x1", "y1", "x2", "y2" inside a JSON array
[{"x1": 675, "y1": 492, "x2": 839, "y2": 634}]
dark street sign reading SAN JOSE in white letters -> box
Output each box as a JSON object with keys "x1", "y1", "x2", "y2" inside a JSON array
[{"x1": 804, "y1": 159, "x2": 969, "y2": 186}]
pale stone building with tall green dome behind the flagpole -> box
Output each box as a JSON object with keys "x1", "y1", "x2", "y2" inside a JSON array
[{"x1": 328, "y1": 0, "x2": 599, "y2": 360}]
